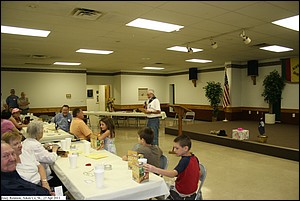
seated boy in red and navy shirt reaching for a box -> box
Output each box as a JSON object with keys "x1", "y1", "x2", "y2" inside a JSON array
[{"x1": 144, "y1": 134, "x2": 201, "y2": 200}]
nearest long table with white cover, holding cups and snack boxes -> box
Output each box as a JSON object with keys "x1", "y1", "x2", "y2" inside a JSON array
[{"x1": 51, "y1": 140, "x2": 169, "y2": 200}]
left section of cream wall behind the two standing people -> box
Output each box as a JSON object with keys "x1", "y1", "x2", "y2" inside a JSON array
[{"x1": 1, "y1": 71, "x2": 86, "y2": 108}]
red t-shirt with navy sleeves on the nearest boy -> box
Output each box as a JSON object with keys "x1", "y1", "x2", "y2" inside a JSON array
[{"x1": 174, "y1": 154, "x2": 200, "y2": 195}]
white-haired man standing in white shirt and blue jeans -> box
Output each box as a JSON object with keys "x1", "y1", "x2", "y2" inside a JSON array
[{"x1": 144, "y1": 89, "x2": 161, "y2": 146}]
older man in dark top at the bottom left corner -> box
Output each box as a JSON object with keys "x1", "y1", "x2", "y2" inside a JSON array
[{"x1": 1, "y1": 140, "x2": 54, "y2": 196}]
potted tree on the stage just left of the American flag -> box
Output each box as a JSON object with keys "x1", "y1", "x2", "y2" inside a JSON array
[{"x1": 203, "y1": 81, "x2": 222, "y2": 121}]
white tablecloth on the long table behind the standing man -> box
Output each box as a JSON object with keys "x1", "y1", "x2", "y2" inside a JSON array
[{"x1": 83, "y1": 111, "x2": 167, "y2": 119}]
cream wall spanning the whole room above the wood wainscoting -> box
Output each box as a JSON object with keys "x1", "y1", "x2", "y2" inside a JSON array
[{"x1": 1, "y1": 58, "x2": 299, "y2": 109}]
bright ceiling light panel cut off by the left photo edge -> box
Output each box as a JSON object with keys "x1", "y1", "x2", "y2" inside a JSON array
[{"x1": 1, "y1": 25, "x2": 50, "y2": 37}]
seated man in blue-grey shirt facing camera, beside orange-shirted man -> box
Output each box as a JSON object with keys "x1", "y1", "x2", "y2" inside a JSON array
[{"x1": 53, "y1": 105, "x2": 72, "y2": 132}]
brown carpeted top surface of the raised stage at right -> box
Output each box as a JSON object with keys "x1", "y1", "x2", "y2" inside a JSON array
[{"x1": 170, "y1": 121, "x2": 299, "y2": 149}]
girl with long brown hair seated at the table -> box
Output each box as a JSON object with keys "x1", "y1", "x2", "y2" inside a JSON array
[{"x1": 97, "y1": 117, "x2": 117, "y2": 154}]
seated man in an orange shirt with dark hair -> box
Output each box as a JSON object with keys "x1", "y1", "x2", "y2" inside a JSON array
[{"x1": 70, "y1": 108, "x2": 93, "y2": 141}]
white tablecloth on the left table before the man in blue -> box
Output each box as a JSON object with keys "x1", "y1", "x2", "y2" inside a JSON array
[{"x1": 21, "y1": 122, "x2": 74, "y2": 143}]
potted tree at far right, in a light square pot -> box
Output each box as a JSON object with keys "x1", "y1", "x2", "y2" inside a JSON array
[{"x1": 261, "y1": 70, "x2": 285, "y2": 124}]
